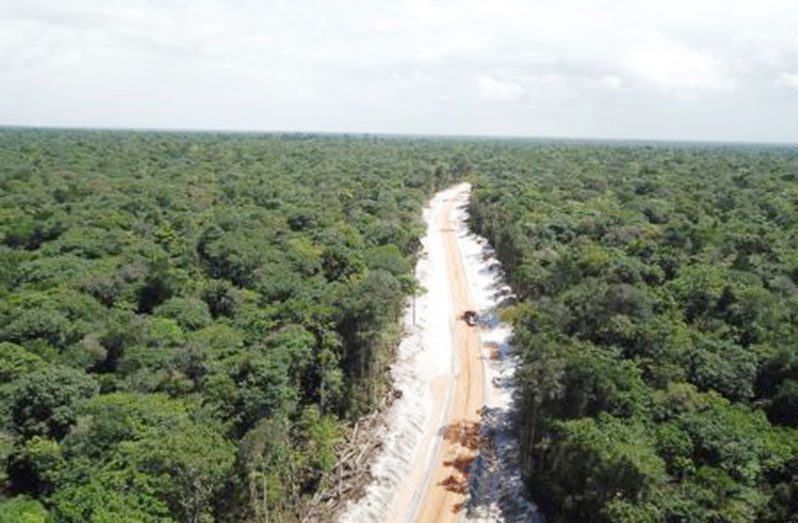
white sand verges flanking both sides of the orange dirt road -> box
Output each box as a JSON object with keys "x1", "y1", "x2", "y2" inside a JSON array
[{"x1": 339, "y1": 184, "x2": 537, "y2": 523}]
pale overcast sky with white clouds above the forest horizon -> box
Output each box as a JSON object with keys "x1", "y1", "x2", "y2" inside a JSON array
[{"x1": 0, "y1": 0, "x2": 798, "y2": 142}]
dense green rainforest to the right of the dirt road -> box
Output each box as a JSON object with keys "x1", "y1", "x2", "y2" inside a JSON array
[{"x1": 471, "y1": 144, "x2": 798, "y2": 522}]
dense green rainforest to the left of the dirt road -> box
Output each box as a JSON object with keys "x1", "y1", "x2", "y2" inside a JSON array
[{"x1": 0, "y1": 129, "x2": 462, "y2": 522}]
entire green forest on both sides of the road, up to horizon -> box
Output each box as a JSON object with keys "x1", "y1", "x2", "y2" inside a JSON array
[{"x1": 0, "y1": 129, "x2": 798, "y2": 523}]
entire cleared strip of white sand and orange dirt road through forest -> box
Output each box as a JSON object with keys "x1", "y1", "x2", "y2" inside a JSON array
[{"x1": 339, "y1": 184, "x2": 537, "y2": 523}]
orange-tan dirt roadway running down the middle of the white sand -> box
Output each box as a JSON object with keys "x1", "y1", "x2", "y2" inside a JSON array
[{"x1": 412, "y1": 186, "x2": 484, "y2": 523}]
